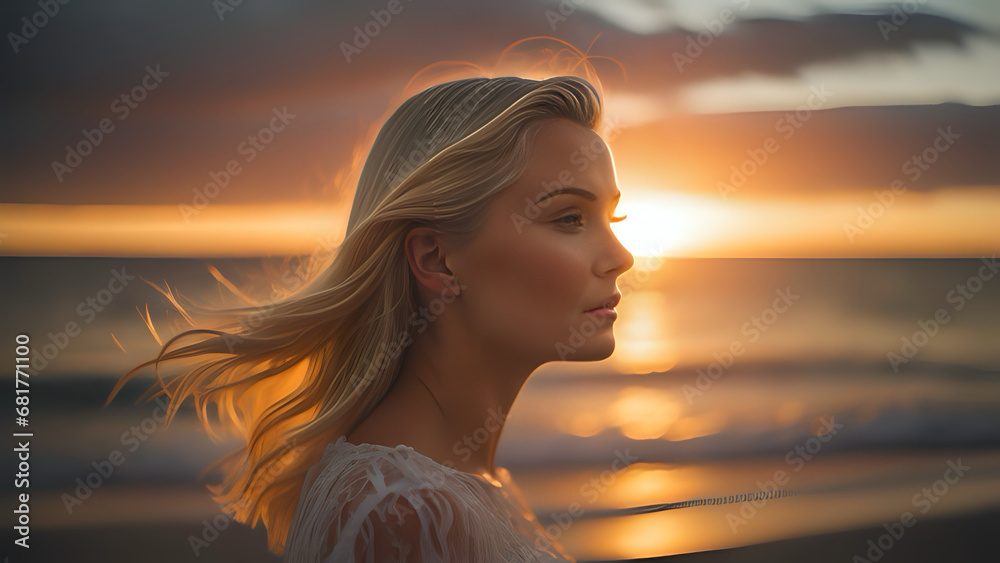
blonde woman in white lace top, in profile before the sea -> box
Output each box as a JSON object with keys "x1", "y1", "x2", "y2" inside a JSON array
[{"x1": 107, "y1": 76, "x2": 633, "y2": 562}]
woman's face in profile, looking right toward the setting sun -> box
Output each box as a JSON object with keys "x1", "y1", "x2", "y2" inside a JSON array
[{"x1": 455, "y1": 118, "x2": 633, "y2": 365}]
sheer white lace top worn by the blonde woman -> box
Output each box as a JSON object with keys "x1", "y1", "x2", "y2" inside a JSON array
[{"x1": 284, "y1": 436, "x2": 575, "y2": 563}]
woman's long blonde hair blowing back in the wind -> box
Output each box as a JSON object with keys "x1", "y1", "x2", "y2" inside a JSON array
[{"x1": 108, "y1": 76, "x2": 601, "y2": 554}]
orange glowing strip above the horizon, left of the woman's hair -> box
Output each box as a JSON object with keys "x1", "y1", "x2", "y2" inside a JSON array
[{"x1": 0, "y1": 203, "x2": 347, "y2": 257}]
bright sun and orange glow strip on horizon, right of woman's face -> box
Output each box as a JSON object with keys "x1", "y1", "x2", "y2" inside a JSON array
[{"x1": 613, "y1": 184, "x2": 1000, "y2": 258}]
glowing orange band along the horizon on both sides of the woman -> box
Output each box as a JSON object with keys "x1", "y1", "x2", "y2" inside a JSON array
[{"x1": 0, "y1": 184, "x2": 1000, "y2": 258}]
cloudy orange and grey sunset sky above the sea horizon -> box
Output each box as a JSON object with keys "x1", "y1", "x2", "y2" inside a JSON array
[{"x1": 0, "y1": 0, "x2": 1000, "y2": 257}]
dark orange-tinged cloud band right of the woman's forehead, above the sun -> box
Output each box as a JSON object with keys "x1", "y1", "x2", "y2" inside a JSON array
[{"x1": 613, "y1": 104, "x2": 1000, "y2": 197}]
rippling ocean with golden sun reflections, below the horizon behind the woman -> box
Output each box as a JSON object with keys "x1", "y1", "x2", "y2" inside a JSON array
[{"x1": 0, "y1": 257, "x2": 1000, "y2": 562}]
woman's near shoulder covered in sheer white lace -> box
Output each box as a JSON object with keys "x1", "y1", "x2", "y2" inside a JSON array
[{"x1": 289, "y1": 438, "x2": 482, "y2": 561}]
